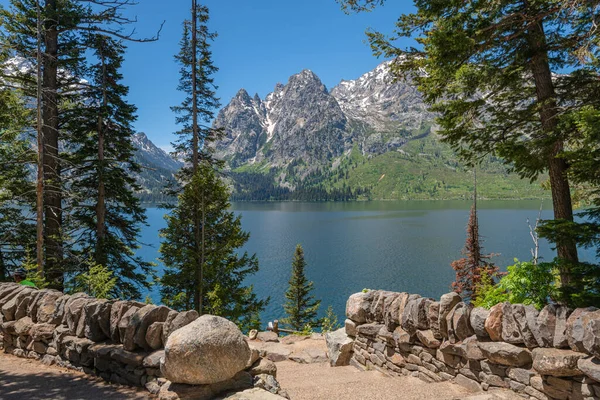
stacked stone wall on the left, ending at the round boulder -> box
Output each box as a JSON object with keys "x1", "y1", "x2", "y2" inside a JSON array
[{"x1": 0, "y1": 283, "x2": 198, "y2": 387}]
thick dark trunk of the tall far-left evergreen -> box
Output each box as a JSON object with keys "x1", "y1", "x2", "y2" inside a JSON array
[{"x1": 42, "y1": 0, "x2": 63, "y2": 290}]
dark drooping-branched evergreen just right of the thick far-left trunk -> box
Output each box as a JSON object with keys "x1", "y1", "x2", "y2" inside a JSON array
[{"x1": 64, "y1": 34, "x2": 152, "y2": 298}]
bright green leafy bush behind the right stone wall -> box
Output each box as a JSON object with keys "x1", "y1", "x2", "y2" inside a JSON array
[{"x1": 473, "y1": 259, "x2": 557, "y2": 309}]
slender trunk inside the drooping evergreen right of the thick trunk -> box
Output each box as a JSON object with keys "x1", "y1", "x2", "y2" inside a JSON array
[{"x1": 95, "y1": 43, "x2": 107, "y2": 265}]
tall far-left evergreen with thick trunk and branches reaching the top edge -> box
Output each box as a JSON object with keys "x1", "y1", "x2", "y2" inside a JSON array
[{"x1": 0, "y1": 0, "x2": 155, "y2": 289}]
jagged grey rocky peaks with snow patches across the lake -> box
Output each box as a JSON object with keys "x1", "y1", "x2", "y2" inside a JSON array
[{"x1": 214, "y1": 62, "x2": 433, "y2": 168}]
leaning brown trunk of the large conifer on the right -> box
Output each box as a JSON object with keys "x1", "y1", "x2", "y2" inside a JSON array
[{"x1": 528, "y1": 16, "x2": 578, "y2": 286}]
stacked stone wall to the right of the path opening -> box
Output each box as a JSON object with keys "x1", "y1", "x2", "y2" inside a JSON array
[{"x1": 345, "y1": 290, "x2": 600, "y2": 399}]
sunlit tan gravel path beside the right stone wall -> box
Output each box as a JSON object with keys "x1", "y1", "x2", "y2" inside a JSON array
[{"x1": 277, "y1": 361, "x2": 476, "y2": 400}]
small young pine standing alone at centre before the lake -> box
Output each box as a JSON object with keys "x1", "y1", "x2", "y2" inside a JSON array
[{"x1": 281, "y1": 245, "x2": 321, "y2": 331}]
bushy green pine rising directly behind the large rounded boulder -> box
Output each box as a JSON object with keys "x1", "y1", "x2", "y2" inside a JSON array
[{"x1": 160, "y1": 162, "x2": 268, "y2": 329}]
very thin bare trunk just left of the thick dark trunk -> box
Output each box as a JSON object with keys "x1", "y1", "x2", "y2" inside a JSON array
[{"x1": 36, "y1": 0, "x2": 44, "y2": 276}]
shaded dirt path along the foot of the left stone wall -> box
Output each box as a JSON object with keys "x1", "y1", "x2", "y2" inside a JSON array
[{"x1": 0, "y1": 350, "x2": 149, "y2": 400}]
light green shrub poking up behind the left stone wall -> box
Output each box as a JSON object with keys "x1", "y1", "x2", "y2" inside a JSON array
[{"x1": 68, "y1": 259, "x2": 118, "y2": 299}]
